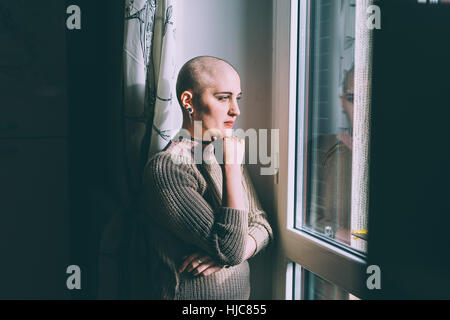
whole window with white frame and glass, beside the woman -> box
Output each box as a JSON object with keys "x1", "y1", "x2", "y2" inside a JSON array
[{"x1": 273, "y1": 0, "x2": 367, "y2": 299}]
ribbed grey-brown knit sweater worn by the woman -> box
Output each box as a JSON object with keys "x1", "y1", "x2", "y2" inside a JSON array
[{"x1": 142, "y1": 138, "x2": 272, "y2": 300}]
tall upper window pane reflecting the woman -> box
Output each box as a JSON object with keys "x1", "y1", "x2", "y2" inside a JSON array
[{"x1": 296, "y1": 0, "x2": 366, "y2": 251}]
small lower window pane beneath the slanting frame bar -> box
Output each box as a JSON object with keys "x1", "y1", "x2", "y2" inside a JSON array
[{"x1": 293, "y1": 264, "x2": 359, "y2": 300}]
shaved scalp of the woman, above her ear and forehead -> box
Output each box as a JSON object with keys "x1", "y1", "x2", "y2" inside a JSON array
[{"x1": 176, "y1": 56, "x2": 237, "y2": 105}]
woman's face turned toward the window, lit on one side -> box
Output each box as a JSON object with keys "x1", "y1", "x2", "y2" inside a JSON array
[{"x1": 193, "y1": 66, "x2": 242, "y2": 140}]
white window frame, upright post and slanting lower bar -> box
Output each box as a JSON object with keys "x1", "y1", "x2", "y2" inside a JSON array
[{"x1": 272, "y1": 0, "x2": 367, "y2": 300}]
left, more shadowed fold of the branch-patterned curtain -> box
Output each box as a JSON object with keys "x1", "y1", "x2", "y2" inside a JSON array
[{"x1": 123, "y1": 0, "x2": 157, "y2": 195}]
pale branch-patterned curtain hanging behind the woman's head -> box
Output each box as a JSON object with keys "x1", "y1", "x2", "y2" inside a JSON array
[{"x1": 124, "y1": 0, "x2": 182, "y2": 198}]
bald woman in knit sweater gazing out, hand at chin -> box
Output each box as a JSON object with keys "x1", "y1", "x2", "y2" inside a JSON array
[{"x1": 142, "y1": 56, "x2": 272, "y2": 299}]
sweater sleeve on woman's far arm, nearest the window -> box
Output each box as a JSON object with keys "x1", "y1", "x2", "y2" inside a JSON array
[{"x1": 243, "y1": 166, "x2": 273, "y2": 256}]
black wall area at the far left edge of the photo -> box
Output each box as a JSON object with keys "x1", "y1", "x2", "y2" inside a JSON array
[{"x1": 0, "y1": 0, "x2": 71, "y2": 299}]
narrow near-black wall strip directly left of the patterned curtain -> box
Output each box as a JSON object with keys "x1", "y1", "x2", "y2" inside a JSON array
[{"x1": 66, "y1": 0, "x2": 126, "y2": 299}]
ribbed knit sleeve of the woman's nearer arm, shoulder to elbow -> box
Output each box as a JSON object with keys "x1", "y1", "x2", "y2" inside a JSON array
[{"x1": 143, "y1": 153, "x2": 248, "y2": 265}]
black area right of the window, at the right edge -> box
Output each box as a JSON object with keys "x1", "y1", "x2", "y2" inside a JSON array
[{"x1": 368, "y1": 0, "x2": 450, "y2": 299}]
